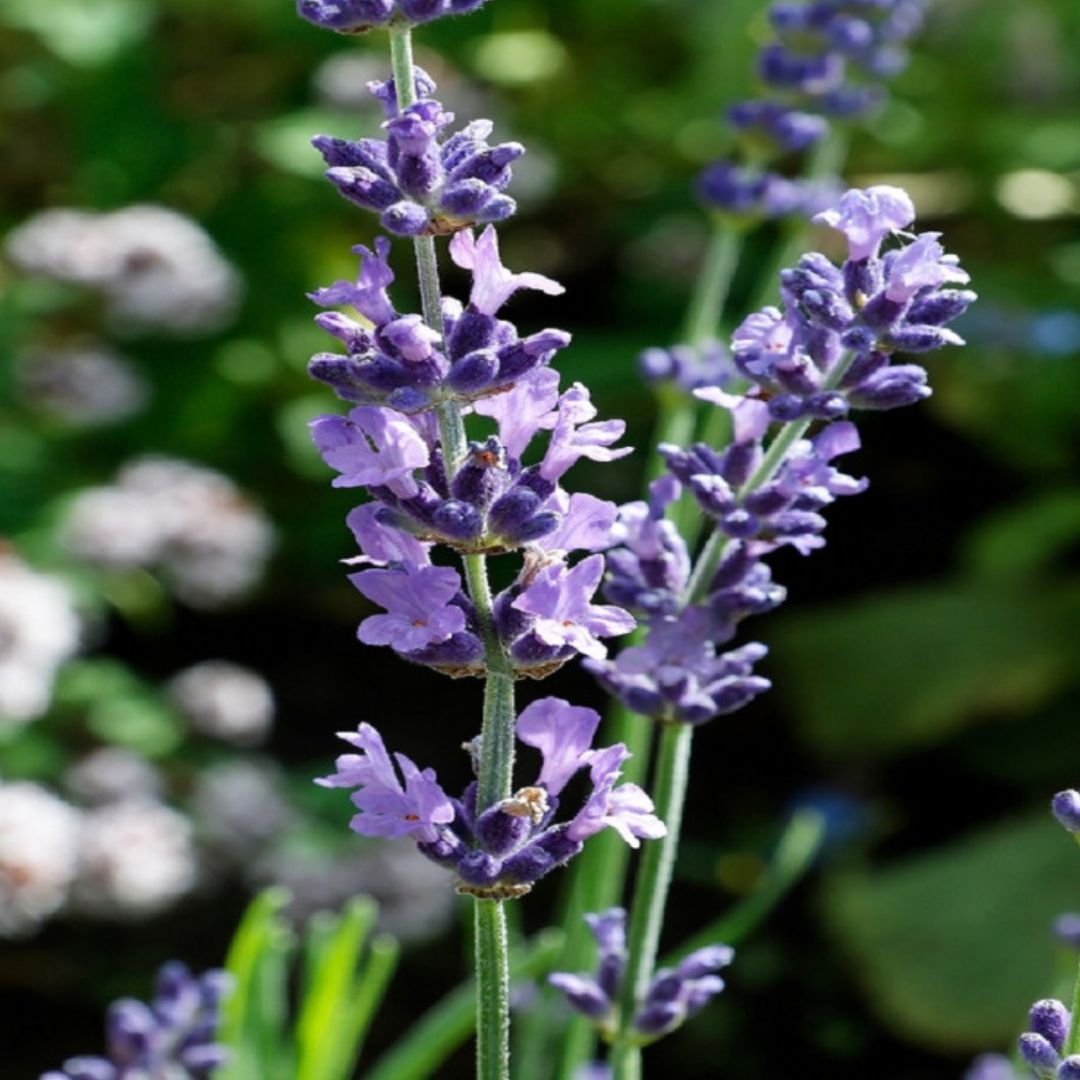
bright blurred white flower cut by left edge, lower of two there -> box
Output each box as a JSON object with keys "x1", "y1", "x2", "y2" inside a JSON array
[{"x1": 0, "y1": 782, "x2": 81, "y2": 937}]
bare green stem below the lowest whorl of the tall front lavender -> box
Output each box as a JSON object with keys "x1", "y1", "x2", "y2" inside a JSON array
[{"x1": 473, "y1": 900, "x2": 510, "y2": 1080}]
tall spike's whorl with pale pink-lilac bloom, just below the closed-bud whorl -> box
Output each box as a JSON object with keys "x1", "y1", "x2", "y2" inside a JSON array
[{"x1": 308, "y1": 227, "x2": 570, "y2": 414}]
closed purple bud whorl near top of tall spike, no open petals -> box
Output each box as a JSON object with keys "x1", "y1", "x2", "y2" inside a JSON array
[{"x1": 312, "y1": 68, "x2": 525, "y2": 237}]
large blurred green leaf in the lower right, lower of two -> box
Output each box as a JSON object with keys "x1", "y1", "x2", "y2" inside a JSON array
[{"x1": 825, "y1": 812, "x2": 1080, "y2": 1051}]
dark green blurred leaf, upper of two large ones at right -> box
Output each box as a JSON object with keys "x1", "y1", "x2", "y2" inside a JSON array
[{"x1": 772, "y1": 581, "x2": 1080, "y2": 757}]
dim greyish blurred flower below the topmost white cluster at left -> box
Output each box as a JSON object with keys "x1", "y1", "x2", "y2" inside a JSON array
[{"x1": 16, "y1": 342, "x2": 149, "y2": 427}]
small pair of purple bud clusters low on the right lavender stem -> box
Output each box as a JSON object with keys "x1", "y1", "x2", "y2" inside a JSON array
[{"x1": 548, "y1": 907, "x2": 734, "y2": 1043}]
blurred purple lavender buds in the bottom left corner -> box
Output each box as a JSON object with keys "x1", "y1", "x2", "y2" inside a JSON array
[{"x1": 41, "y1": 961, "x2": 230, "y2": 1080}]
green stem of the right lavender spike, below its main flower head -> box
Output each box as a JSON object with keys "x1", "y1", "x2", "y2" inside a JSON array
[{"x1": 610, "y1": 724, "x2": 693, "y2": 1080}]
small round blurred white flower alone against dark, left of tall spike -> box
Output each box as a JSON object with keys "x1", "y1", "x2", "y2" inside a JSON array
[{"x1": 168, "y1": 660, "x2": 274, "y2": 746}]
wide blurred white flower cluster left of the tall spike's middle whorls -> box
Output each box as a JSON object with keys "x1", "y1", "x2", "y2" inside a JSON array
[{"x1": 62, "y1": 457, "x2": 273, "y2": 608}]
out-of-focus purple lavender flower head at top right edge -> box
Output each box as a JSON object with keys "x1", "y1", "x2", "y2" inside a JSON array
[{"x1": 699, "y1": 0, "x2": 926, "y2": 218}]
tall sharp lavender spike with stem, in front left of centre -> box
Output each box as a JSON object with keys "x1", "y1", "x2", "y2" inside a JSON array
[{"x1": 299, "y1": 2, "x2": 664, "y2": 1077}]
